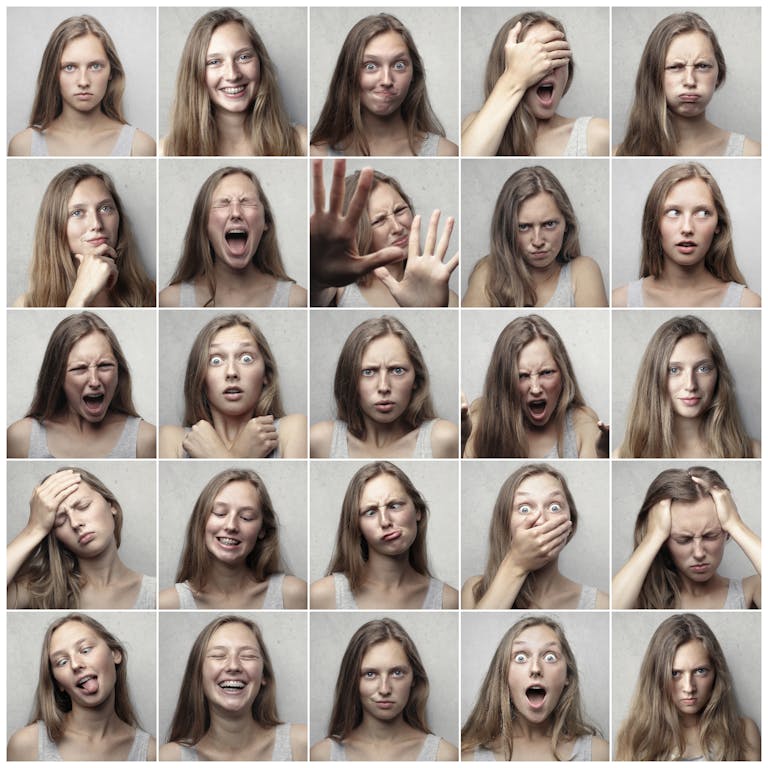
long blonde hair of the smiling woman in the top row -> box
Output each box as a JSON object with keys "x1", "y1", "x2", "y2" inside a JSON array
[{"x1": 165, "y1": 8, "x2": 306, "y2": 156}]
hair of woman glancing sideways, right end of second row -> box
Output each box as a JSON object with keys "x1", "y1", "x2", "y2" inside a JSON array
[{"x1": 640, "y1": 162, "x2": 746, "y2": 285}]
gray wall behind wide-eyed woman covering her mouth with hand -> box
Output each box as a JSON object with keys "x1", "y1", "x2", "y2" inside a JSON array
[{"x1": 461, "y1": 460, "x2": 610, "y2": 593}]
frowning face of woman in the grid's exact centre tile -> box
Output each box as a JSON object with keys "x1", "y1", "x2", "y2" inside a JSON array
[{"x1": 357, "y1": 334, "x2": 416, "y2": 424}]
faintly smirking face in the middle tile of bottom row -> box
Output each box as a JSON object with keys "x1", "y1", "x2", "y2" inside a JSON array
[{"x1": 358, "y1": 640, "x2": 413, "y2": 721}]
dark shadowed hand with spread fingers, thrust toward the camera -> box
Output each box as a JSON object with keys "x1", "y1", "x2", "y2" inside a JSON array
[{"x1": 309, "y1": 160, "x2": 403, "y2": 292}]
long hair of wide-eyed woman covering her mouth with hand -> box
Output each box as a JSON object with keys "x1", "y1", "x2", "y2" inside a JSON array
[{"x1": 472, "y1": 464, "x2": 579, "y2": 610}]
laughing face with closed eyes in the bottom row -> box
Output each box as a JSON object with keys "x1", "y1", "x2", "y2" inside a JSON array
[{"x1": 203, "y1": 621, "x2": 266, "y2": 712}]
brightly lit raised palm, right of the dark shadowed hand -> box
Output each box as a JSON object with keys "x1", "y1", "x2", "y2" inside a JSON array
[{"x1": 373, "y1": 211, "x2": 459, "y2": 307}]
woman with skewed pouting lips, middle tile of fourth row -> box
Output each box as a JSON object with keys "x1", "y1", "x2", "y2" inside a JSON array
[{"x1": 310, "y1": 461, "x2": 459, "y2": 610}]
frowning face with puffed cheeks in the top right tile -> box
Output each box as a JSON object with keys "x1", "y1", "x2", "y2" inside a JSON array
[{"x1": 664, "y1": 30, "x2": 718, "y2": 117}]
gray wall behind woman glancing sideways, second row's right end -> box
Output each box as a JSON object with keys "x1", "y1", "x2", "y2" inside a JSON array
[{"x1": 611, "y1": 157, "x2": 762, "y2": 293}]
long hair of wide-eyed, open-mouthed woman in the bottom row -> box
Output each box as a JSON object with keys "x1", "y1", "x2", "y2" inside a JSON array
[{"x1": 461, "y1": 615, "x2": 597, "y2": 761}]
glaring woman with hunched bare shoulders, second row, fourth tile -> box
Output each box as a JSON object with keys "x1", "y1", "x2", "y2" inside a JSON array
[{"x1": 463, "y1": 165, "x2": 608, "y2": 307}]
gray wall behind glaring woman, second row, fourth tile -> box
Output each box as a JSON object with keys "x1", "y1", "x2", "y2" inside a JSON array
[{"x1": 461, "y1": 158, "x2": 609, "y2": 296}]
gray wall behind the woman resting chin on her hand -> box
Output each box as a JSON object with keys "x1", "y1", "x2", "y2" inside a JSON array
[{"x1": 6, "y1": 159, "x2": 157, "y2": 305}]
